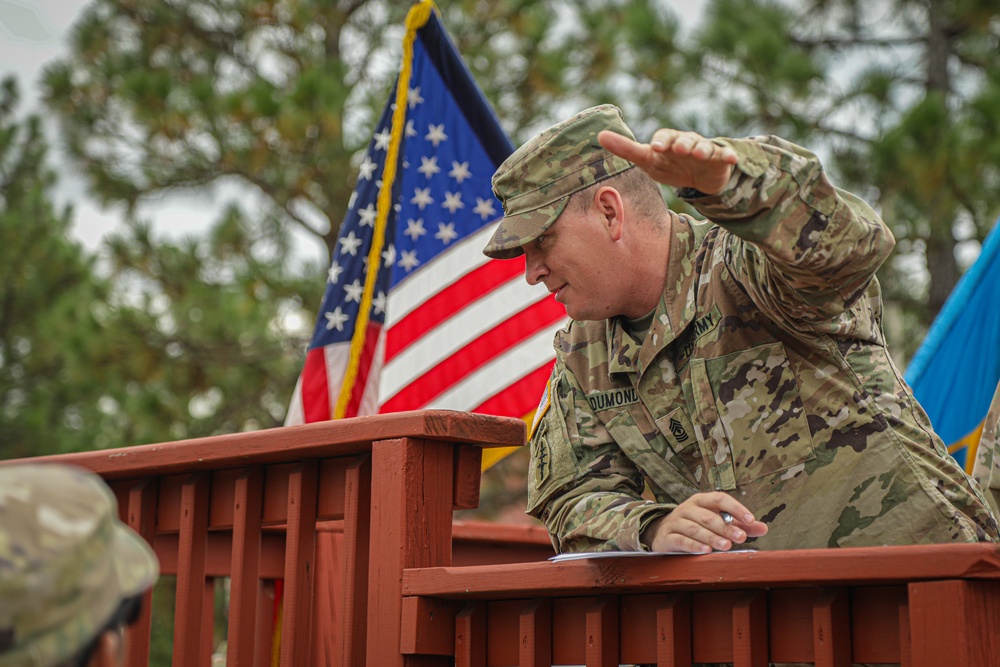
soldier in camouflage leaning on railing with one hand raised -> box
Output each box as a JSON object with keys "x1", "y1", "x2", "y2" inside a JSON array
[{"x1": 484, "y1": 106, "x2": 998, "y2": 552}]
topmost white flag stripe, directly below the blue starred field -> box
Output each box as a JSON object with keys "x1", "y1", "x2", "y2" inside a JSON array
[{"x1": 385, "y1": 224, "x2": 497, "y2": 328}]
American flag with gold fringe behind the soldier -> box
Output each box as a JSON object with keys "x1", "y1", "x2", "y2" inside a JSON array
[{"x1": 286, "y1": 12, "x2": 566, "y2": 436}]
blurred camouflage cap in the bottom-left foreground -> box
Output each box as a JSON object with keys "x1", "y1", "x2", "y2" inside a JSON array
[{"x1": 0, "y1": 463, "x2": 159, "y2": 667}]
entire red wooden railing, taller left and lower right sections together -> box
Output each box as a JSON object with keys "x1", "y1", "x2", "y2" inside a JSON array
[{"x1": 7, "y1": 411, "x2": 1000, "y2": 667}]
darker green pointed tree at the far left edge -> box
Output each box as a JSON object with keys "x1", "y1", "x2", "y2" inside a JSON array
[{"x1": 0, "y1": 78, "x2": 121, "y2": 457}]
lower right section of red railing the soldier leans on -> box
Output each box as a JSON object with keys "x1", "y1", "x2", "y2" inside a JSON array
[{"x1": 401, "y1": 544, "x2": 1000, "y2": 667}]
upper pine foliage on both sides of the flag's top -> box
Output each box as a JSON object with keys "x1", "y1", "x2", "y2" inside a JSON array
[{"x1": 44, "y1": 0, "x2": 682, "y2": 266}]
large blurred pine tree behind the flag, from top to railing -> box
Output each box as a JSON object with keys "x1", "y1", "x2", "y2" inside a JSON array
[{"x1": 19, "y1": 0, "x2": 684, "y2": 462}]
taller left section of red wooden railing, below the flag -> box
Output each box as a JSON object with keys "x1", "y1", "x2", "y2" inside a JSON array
[{"x1": 5, "y1": 411, "x2": 552, "y2": 667}]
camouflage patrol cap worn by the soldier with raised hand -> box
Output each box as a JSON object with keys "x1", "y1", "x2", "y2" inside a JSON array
[{"x1": 483, "y1": 104, "x2": 635, "y2": 259}]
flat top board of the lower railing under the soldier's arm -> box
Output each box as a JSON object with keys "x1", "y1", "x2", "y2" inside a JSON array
[{"x1": 403, "y1": 543, "x2": 1000, "y2": 599}]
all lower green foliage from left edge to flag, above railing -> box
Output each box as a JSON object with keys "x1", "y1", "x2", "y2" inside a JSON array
[{"x1": 0, "y1": 70, "x2": 320, "y2": 457}]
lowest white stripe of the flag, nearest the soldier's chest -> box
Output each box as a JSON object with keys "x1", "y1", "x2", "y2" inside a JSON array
[{"x1": 423, "y1": 322, "x2": 565, "y2": 410}]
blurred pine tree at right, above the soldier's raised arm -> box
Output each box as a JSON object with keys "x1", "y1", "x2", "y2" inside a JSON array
[{"x1": 689, "y1": 0, "x2": 1000, "y2": 365}]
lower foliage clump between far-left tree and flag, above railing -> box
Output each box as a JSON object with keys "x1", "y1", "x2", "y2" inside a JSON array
[{"x1": 91, "y1": 208, "x2": 315, "y2": 443}]
